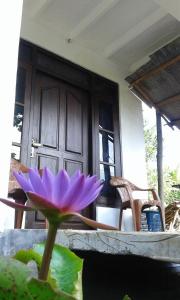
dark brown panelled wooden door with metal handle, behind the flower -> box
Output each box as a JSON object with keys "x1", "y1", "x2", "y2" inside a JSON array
[{"x1": 26, "y1": 72, "x2": 88, "y2": 228}]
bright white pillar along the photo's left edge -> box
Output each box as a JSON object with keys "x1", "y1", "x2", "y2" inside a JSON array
[{"x1": 0, "y1": 0, "x2": 23, "y2": 231}]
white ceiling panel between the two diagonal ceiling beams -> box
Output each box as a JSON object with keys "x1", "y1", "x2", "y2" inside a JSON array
[{"x1": 77, "y1": 0, "x2": 158, "y2": 51}]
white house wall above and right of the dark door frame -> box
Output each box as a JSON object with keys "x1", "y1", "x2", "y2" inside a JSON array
[{"x1": 21, "y1": 15, "x2": 146, "y2": 185}]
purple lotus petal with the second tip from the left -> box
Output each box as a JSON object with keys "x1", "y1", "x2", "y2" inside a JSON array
[{"x1": 29, "y1": 169, "x2": 48, "y2": 198}]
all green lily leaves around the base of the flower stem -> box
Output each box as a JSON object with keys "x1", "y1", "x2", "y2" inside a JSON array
[{"x1": 0, "y1": 244, "x2": 83, "y2": 300}]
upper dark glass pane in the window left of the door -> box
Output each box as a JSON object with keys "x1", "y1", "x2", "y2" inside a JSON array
[{"x1": 16, "y1": 68, "x2": 26, "y2": 103}]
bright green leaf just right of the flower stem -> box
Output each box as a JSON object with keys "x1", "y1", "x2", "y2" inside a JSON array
[{"x1": 34, "y1": 244, "x2": 83, "y2": 300}]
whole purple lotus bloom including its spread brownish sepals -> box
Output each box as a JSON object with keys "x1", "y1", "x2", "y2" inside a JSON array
[{"x1": 0, "y1": 168, "x2": 117, "y2": 230}]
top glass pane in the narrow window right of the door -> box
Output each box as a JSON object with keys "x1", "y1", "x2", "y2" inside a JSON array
[{"x1": 99, "y1": 102, "x2": 114, "y2": 131}]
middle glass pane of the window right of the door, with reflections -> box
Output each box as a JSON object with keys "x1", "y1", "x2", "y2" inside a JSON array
[{"x1": 99, "y1": 131, "x2": 114, "y2": 164}]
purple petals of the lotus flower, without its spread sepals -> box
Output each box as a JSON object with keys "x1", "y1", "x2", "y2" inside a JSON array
[{"x1": 14, "y1": 168, "x2": 102, "y2": 213}]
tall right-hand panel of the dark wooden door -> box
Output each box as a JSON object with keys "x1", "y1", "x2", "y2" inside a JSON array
[{"x1": 62, "y1": 85, "x2": 88, "y2": 174}]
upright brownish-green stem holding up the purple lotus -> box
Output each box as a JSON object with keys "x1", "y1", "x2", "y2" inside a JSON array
[{"x1": 39, "y1": 223, "x2": 58, "y2": 280}]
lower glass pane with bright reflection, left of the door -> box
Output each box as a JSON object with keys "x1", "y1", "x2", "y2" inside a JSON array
[{"x1": 13, "y1": 104, "x2": 24, "y2": 143}]
